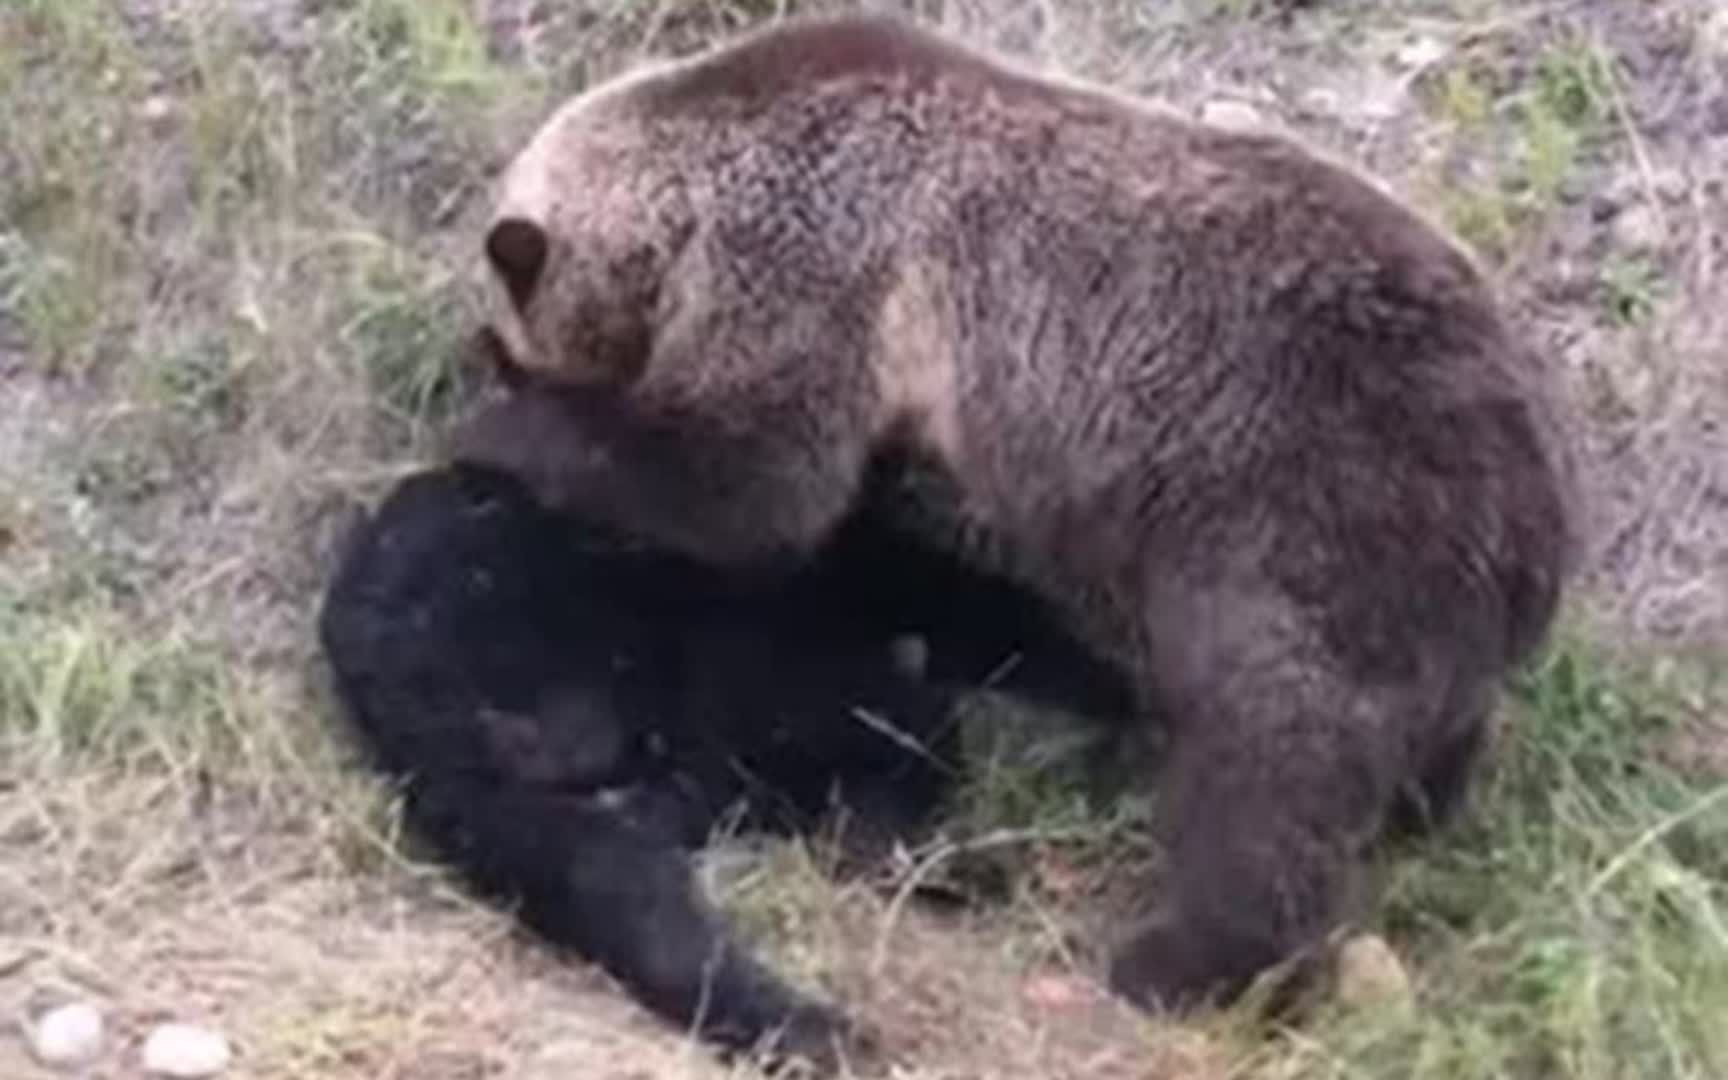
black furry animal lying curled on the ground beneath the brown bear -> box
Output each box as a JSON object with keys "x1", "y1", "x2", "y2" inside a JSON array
[{"x1": 320, "y1": 467, "x2": 1127, "y2": 1058}]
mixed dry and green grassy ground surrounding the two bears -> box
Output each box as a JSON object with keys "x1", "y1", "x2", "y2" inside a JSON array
[{"x1": 0, "y1": 0, "x2": 1728, "y2": 1080}]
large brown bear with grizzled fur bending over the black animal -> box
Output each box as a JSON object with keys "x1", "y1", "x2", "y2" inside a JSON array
[{"x1": 458, "y1": 16, "x2": 1572, "y2": 1006}]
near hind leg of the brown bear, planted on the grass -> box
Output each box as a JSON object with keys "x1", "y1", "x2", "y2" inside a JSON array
[{"x1": 1111, "y1": 596, "x2": 1420, "y2": 1009}]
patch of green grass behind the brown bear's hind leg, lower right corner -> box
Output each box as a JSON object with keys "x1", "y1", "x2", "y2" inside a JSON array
[{"x1": 1251, "y1": 651, "x2": 1728, "y2": 1077}]
